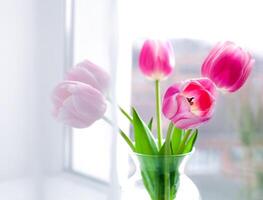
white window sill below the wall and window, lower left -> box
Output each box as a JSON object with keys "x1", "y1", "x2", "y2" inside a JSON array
[{"x1": 0, "y1": 172, "x2": 108, "y2": 200}]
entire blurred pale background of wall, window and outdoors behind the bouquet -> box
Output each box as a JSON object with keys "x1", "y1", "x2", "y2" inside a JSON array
[{"x1": 0, "y1": 0, "x2": 263, "y2": 200}]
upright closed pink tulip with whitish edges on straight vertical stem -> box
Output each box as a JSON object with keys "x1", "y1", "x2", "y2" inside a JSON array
[{"x1": 139, "y1": 40, "x2": 175, "y2": 80}]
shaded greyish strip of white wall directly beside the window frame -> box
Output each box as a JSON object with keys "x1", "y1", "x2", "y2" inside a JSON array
[{"x1": 34, "y1": 0, "x2": 65, "y2": 172}]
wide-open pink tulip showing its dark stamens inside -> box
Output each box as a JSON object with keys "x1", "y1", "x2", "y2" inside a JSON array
[{"x1": 162, "y1": 78, "x2": 216, "y2": 129}]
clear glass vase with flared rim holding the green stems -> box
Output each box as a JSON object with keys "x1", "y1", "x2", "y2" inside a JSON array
[{"x1": 122, "y1": 153, "x2": 201, "y2": 200}]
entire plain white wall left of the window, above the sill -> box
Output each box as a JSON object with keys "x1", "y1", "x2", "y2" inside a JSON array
[{"x1": 0, "y1": 0, "x2": 64, "y2": 199}]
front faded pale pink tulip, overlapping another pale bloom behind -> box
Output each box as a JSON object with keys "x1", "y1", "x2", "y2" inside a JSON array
[{"x1": 52, "y1": 81, "x2": 107, "y2": 128}]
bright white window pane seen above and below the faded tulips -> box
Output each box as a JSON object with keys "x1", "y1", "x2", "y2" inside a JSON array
[{"x1": 72, "y1": 0, "x2": 113, "y2": 182}]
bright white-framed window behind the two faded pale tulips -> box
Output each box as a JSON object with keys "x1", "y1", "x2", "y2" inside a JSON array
[{"x1": 65, "y1": 0, "x2": 130, "y2": 192}]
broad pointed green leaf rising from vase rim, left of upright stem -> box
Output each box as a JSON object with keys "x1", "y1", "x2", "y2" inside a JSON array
[{"x1": 132, "y1": 108, "x2": 158, "y2": 155}]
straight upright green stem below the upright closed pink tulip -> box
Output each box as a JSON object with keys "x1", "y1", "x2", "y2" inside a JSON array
[{"x1": 155, "y1": 80, "x2": 163, "y2": 149}]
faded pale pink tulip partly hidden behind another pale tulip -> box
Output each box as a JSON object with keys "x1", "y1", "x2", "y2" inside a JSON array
[{"x1": 66, "y1": 60, "x2": 110, "y2": 93}]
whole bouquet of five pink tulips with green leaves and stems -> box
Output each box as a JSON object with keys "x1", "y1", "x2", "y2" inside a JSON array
[{"x1": 53, "y1": 40, "x2": 254, "y2": 200}]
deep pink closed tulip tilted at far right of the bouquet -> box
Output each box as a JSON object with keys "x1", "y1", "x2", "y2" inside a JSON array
[{"x1": 202, "y1": 42, "x2": 255, "y2": 92}]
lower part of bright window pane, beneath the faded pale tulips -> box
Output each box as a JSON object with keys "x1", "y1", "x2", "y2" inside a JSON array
[{"x1": 72, "y1": 121, "x2": 112, "y2": 181}]
